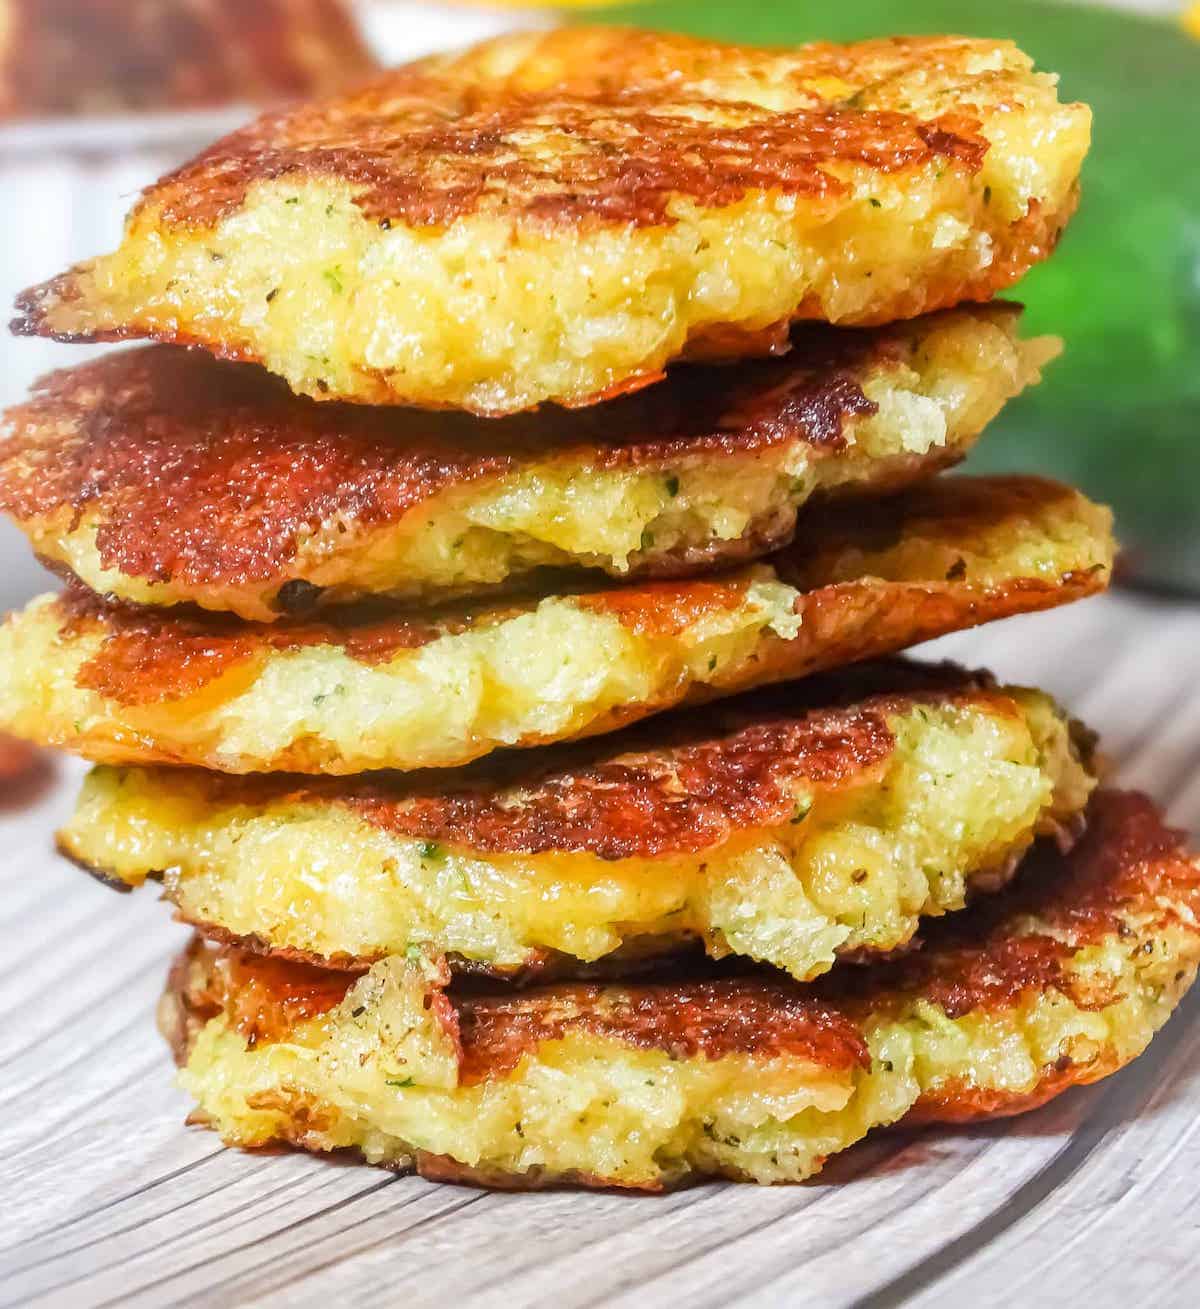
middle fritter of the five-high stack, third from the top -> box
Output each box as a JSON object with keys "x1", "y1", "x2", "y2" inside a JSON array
[{"x1": 0, "y1": 478, "x2": 1112, "y2": 774}]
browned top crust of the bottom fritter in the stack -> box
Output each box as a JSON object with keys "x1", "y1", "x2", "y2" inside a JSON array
[{"x1": 169, "y1": 791, "x2": 1200, "y2": 1146}]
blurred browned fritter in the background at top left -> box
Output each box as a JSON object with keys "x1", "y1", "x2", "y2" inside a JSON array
[{"x1": 0, "y1": 0, "x2": 376, "y2": 118}]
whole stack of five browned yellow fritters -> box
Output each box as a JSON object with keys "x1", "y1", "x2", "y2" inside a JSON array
[{"x1": 0, "y1": 29, "x2": 1200, "y2": 1189}]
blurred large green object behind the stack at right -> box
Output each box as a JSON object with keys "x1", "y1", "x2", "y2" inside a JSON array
[{"x1": 586, "y1": 0, "x2": 1200, "y2": 593}]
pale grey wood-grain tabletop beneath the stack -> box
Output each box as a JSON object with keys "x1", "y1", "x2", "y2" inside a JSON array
[{"x1": 0, "y1": 596, "x2": 1200, "y2": 1309}]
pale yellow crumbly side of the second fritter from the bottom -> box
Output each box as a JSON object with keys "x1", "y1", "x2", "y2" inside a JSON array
[{"x1": 60, "y1": 690, "x2": 1094, "y2": 979}]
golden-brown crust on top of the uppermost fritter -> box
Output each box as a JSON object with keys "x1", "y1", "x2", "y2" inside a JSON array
[{"x1": 16, "y1": 30, "x2": 995, "y2": 228}]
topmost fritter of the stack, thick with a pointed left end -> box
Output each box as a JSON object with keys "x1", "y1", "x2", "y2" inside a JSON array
[{"x1": 14, "y1": 27, "x2": 1090, "y2": 415}]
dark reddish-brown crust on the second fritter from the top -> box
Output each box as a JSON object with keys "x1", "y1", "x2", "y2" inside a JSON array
[{"x1": 0, "y1": 314, "x2": 910, "y2": 609}]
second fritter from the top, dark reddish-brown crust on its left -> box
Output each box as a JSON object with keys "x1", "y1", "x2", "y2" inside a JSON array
[{"x1": 0, "y1": 305, "x2": 1056, "y2": 620}]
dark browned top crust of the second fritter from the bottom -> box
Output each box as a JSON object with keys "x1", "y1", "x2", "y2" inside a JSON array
[{"x1": 105, "y1": 661, "x2": 1018, "y2": 860}]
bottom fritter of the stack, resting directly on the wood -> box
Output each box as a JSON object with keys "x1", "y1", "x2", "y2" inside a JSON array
[{"x1": 160, "y1": 792, "x2": 1200, "y2": 1190}]
